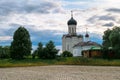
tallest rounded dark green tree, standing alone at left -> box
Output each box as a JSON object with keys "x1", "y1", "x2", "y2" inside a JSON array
[{"x1": 10, "y1": 27, "x2": 32, "y2": 59}]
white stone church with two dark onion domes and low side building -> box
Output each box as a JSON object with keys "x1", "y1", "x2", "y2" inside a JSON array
[{"x1": 62, "y1": 14, "x2": 101, "y2": 56}]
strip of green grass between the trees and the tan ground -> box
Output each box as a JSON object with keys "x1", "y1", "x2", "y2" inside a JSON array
[{"x1": 0, "y1": 57, "x2": 120, "y2": 68}]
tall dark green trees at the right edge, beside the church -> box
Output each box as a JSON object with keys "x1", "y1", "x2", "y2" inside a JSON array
[{"x1": 103, "y1": 27, "x2": 120, "y2": 58}]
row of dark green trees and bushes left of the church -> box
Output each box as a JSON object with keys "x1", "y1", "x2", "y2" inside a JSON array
[{"x1": 0, "y1": 27, "x2": 73, "y2": 59}]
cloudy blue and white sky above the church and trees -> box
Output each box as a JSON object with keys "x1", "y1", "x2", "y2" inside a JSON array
[{"x1": 0, "y1": 0, "x2": 120, "y2": 49}]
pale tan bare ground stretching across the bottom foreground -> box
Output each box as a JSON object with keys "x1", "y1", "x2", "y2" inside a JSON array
[{"x1": 0, "y1": 65, "x2": 120, "y2": 80}]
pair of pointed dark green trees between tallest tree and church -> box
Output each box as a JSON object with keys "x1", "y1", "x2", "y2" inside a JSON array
[{"x1": 32, "y1": 41, "x2": 59, "y2": 59}]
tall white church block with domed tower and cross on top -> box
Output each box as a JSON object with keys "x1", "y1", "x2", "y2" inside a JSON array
[{"x1": 62, "y1": 11, "x2": 83, "y2": 56}]
